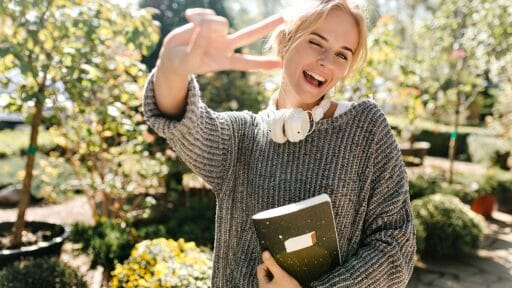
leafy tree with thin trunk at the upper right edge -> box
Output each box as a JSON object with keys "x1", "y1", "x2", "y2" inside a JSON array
[{"x1": 417, "y1": 0, "x2": 512, "y2": 182}]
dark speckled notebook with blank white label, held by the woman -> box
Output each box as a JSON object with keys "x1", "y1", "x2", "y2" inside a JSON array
[{"x1": 252, "y1": 194, "x2": 340, "y2": 286}]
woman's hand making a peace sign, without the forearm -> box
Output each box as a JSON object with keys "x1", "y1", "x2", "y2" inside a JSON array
[{"x1": 160, "y1": 8, "x2": 283, "y2": 76}]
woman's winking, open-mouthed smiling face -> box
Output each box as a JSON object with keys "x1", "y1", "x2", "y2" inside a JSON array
[{"x1": 279, "y1": 9, "x2": 359, "y2": 110}]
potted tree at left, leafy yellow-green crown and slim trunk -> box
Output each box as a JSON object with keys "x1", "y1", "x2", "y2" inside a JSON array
[{"x1": 0, "y1": 0, "x2": 158, "y2": 244}]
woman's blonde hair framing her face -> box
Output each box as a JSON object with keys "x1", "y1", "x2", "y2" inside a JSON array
[{"x1": 268, "y1": 0, "x2": 368, "y2": 76}]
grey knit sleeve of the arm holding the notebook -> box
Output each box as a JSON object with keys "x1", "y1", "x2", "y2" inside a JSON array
[{"x1": 311, "y1": 109, "x2": 416, "y2": 288}]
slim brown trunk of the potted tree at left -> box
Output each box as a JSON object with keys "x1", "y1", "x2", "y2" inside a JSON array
[{"x1": 12, "y1": 98, "x2": 43, "y2": 246}]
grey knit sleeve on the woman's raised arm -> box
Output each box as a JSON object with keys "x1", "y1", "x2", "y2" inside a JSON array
[{"x1": 143, "y1": 71, "x2": 232, "y2": 191}]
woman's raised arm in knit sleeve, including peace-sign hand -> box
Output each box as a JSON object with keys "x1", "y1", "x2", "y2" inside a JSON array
[{"x1": 143, "y1": 9, "x2": 283, "y2": 188}]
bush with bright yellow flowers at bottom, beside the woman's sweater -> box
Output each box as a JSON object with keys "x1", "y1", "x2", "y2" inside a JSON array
[{"x1": 111, "y1": 238, "x2": 212, "y2": 288}]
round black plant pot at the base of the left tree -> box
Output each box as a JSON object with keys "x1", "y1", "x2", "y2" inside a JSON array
[{"x1": 0, "y1": 221, "x2": 70, "y2": 268}]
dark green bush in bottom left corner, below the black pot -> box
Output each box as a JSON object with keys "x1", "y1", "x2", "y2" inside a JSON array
[{"x1": 0, "y1": 258, "x2": 87, "y2": 288}]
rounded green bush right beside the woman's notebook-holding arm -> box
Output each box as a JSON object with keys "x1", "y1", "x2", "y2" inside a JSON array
[{"x1": 412, "y1": 194, "x2": 485, "y2": 257}]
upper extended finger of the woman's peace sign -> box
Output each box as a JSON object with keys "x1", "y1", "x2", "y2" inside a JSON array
[{"x1": 229, "y1": 14, "x2": 284, "y2": 49}]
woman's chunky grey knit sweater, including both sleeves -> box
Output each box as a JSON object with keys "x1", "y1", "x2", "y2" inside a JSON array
[{"x1": 143, "y1": 73, "x2": 416, "y2": 288}]
